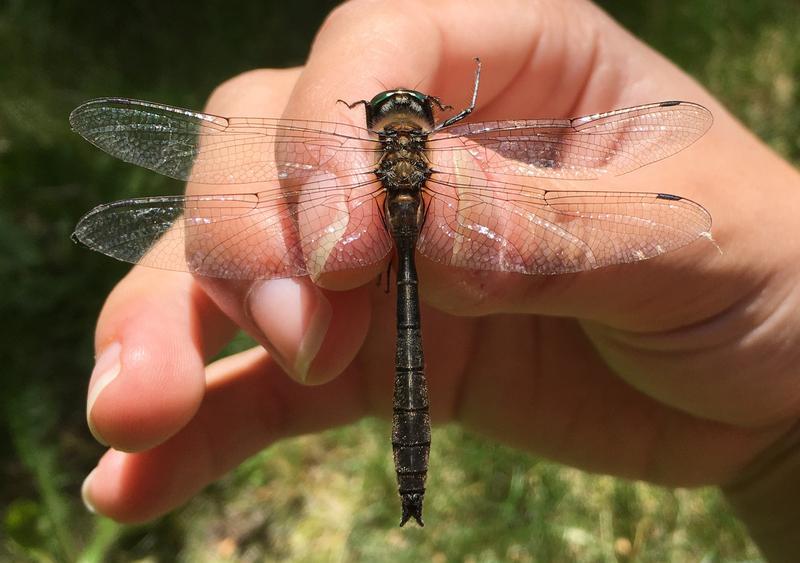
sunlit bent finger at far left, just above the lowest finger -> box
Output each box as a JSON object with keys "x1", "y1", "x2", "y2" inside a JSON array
[{"x1": 87, "y1": 267, "x2": 235, "y2": 451}]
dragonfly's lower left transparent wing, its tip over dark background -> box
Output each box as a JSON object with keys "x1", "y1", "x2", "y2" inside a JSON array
[{"x1": 73, "y1": 174, "x2": 391, "y2": 279}]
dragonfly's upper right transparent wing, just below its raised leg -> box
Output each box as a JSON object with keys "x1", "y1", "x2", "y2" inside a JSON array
[{"x1": 429, "y1": 101, "x2": 713, "y2": 180}]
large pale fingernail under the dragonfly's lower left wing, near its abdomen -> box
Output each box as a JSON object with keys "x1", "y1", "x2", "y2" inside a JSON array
[{"x1": 249, "y1": 278, "x2": 333, "y2": 383}]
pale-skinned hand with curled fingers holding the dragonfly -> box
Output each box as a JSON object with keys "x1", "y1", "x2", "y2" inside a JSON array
[{"x1": 84, "y1": 0, "x2": 800, "y2": 560}]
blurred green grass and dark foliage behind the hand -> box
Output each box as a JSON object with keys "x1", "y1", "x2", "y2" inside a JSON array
[{"x1": 0, "y1": 0, "x2": 800, "y2": 561}]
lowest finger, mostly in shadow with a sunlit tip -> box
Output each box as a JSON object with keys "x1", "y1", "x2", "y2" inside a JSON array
[{"x1": 83, "y1": 348, "x2": 365, "y2": 522}]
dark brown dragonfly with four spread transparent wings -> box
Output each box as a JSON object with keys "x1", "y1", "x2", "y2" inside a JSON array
[{"x1": 69, "y1": 59, "x2": 713, "y2": 526}]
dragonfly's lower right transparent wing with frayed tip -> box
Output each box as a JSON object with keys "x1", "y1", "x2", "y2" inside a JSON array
[{"x1": 418, "y1": 175, "x2": 711, "y2": 275}]
